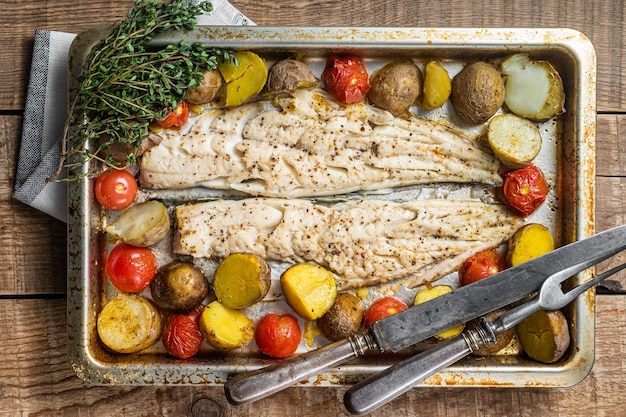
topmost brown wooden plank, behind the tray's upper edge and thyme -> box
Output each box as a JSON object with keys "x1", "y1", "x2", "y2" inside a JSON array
[{"x1": 0, "y1": 0, "x2": 626, "y2": 111}]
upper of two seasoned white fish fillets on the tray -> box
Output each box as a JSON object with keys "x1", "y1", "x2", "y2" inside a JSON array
[{"x1": 140, "y1": 89, "x2": 501, "y2": 198}]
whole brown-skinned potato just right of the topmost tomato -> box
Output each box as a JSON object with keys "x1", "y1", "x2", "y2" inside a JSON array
[{"x1": 367, "y1": 62, "x2": 423, "y2": 116}]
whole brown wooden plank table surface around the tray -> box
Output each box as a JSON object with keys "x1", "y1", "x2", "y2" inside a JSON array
[{"x1": 0, "y1": 0, "x2": 626, "y2": 417}]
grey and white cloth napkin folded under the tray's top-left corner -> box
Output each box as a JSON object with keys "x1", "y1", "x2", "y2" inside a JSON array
[{"x1": 13, "y1": 0, "x2": 254, "y2": 222}]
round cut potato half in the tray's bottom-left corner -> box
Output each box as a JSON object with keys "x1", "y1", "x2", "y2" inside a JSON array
[{"x1": 96, "y1": 293, "x2": 163, "y2": 353}]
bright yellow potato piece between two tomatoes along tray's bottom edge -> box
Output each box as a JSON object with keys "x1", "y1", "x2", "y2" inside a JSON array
[{"x1": 200, "y1": 301, "x2": 254, "y2": 350}]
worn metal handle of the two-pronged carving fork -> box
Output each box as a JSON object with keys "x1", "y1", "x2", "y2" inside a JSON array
[{"x1": 343, "y1": 323, "x2": 495, "y2": 415}]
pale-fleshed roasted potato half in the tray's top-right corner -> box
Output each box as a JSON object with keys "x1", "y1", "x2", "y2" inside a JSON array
[{"x1": 501, "y1": 54, "x2": 565, "y2": 121}]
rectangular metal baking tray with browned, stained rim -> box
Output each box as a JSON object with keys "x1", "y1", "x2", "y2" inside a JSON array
[{"x1": 68, "y1": 27, "x2": 596, "y2": 387}]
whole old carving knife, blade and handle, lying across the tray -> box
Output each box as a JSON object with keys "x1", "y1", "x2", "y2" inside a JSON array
[{"x1": 224, "y1": 225, "x2": 626, "y2": 405}]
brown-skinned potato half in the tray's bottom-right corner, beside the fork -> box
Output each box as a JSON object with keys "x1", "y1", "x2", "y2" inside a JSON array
[{"x1": 517, "y1": 310, "x2": 570, "y2": 363}]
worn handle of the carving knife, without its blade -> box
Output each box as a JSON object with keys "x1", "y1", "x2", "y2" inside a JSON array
[{"x1": 224, "y1": 331, "x2": 376, "y2": 405}]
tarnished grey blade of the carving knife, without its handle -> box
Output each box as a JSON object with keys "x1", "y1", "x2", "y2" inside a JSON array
[{"x1": 370, "y1": 221, "x2": 626, "y2": 352}]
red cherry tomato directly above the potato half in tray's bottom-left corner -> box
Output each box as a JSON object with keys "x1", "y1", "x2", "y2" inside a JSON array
[{"x1": 104, "y1": 243, "x2": 157, "y2": 293}]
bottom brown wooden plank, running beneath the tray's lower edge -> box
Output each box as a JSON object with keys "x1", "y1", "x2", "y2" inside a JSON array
[{"x1": 0, "y1": 295, "x2": 626, "y2": 417}]
